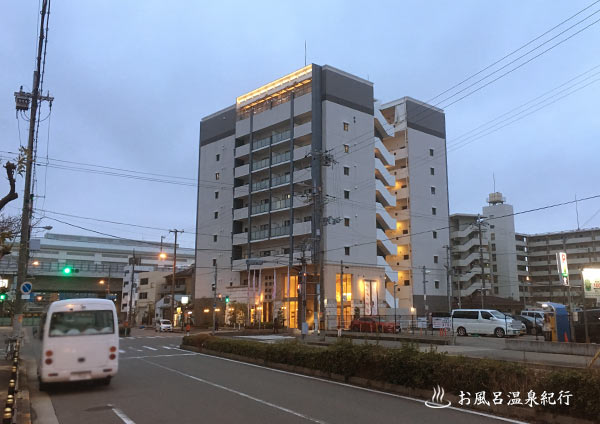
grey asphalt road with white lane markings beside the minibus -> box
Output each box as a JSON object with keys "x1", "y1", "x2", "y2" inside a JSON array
[{"x1": 35, "y1": 331, "x2": 528, "y2": 424}]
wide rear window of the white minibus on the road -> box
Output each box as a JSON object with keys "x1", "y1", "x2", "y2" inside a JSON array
[{"x1": 50, "y1": 311, "x2": 115, "y2": 337}]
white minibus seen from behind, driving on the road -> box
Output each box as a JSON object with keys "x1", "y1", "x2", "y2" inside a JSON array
[{"x1": 38, "y1": 299, "x2": 119, "y2": 390}]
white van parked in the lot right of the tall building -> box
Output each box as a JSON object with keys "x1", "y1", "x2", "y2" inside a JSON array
[{"x1": 452, "y1": 309, "x2": 521, "y2": 337}]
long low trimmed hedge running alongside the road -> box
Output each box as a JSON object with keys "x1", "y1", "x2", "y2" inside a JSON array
[{"x1": 183, "y1": 334, "x2": 600, "y2": 422}]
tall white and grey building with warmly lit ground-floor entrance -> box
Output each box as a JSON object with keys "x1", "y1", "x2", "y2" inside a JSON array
[{"x1": 195, "y1": 64, "x2": 449, "y2": 328}]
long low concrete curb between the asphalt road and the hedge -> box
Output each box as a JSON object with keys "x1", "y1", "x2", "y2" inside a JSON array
[{"x1": 180, "y1": 344, "x2": 596, "y2": 424}]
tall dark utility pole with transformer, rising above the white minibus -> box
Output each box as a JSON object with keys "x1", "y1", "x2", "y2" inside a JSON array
[{"x1": 13, "y1": 0, "x2": 53, "y2": 336}]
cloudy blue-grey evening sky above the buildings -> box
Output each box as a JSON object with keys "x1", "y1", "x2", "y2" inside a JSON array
[{"x1": 0, "y1": 0, "x2": 600, "y2": 247}]
